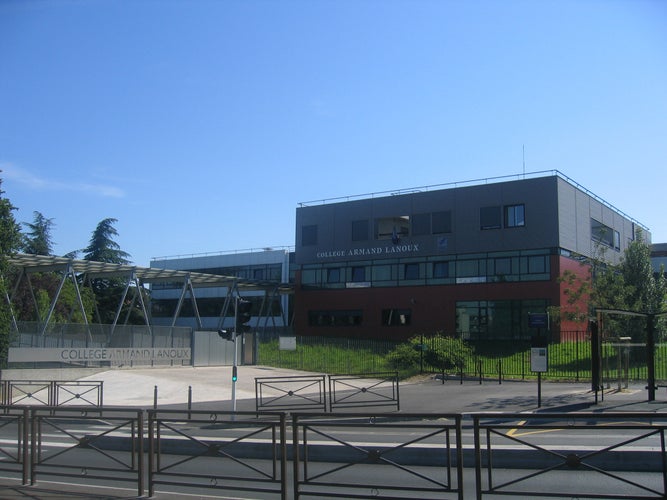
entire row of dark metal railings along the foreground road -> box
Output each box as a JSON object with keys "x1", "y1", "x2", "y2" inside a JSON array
[{"x1": 0, "y1": 406, "x2": 667, "y2": 500}]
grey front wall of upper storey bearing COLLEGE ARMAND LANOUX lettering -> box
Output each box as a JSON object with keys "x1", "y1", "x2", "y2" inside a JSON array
[{"x1": 296, "y1": 177, "x2": 559, "y2": 264}]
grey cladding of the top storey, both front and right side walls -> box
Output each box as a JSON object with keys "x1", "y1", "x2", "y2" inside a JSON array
[{"x1": 296, "y1": 175, "x2": 650, "y2": 265}]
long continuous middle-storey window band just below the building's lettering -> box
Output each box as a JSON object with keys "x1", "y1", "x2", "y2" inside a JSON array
[{"x1": 301, "y1": 250, "x2": 550, "y2": 288}]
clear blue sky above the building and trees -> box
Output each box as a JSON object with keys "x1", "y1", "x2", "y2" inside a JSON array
[{"x1": 0, "y1": 0, "x2": 667, "y2": 266}]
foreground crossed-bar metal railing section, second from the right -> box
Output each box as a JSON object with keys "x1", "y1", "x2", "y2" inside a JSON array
[{"x1": 292, "y1": 414, "x2": 463, "y2": 499}]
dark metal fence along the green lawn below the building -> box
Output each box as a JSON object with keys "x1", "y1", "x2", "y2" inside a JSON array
[{"x1": 256, "y1": 331, "x2": 667, "y2": 386}]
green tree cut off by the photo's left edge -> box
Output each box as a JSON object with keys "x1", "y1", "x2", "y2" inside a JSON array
[{"x1": 0, "y1": 179, "x2": 21, "y2": 365}]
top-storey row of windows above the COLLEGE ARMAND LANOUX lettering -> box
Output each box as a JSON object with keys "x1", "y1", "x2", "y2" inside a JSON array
[{"x1": 301, "y1": 204, "x2": 526, "y2": 246}]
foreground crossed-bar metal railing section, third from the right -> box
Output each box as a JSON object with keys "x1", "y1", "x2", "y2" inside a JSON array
[{"x1": 148, "y1": 410, "x2": 287, "y2": 499}]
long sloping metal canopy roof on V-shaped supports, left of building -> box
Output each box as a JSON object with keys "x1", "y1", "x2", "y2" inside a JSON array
[{"x1": 9, "y1": 254, "x2": 294, "y2": 294}]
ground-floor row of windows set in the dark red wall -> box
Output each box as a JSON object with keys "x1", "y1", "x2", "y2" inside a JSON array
[{"x1": 308, "y1": 299, "x2": 549, "y2": 340}]
